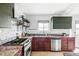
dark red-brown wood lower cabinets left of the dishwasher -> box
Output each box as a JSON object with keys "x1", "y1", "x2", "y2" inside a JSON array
[{"x1": 32, "y1": 37, "x2": 51, "y2": 51}]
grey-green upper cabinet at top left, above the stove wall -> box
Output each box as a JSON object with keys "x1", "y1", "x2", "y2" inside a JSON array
[{"x1": 0, "y1": 3, "x2": 13, "y2": 28}]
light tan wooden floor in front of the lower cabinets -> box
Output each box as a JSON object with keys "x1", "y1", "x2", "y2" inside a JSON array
[{"x1": 32, "y1": 51, "x2": 71, "y2": 56}]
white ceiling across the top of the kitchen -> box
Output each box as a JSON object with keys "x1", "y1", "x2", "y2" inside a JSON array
[{"x1": 15, "y1": 3, "x2": 79, "y2": 15}]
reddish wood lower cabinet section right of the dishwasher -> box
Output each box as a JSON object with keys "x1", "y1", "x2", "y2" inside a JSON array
[{"x1": 61, "y1": 37, "x2": 75, "y2": 51}]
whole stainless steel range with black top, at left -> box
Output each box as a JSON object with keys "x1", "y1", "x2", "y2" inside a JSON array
[{"x1": 3, "y1": 38, "x2": 31, "y2": 56}]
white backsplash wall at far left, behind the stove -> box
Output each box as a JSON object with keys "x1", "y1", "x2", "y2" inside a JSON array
[{"x1": 0, "y1": 27, "x2": 16, "y2": 44}]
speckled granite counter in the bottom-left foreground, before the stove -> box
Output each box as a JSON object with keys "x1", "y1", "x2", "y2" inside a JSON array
[{"x1": 0, "y1": 46, "x2": 22, "y2": 56}]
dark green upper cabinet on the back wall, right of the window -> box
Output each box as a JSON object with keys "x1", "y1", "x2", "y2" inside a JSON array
[{"x1": 51, "y1": 16, "x2": 72, "y2": 29}]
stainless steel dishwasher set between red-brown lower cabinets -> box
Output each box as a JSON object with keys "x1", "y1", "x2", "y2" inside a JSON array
[{"x1": 51, "y1": 38, "x2": 61, "y2": 51}]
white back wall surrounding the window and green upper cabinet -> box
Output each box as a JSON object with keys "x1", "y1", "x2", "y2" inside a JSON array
[{"x1": 26, "y1": 15, "x2": 75, "y2": 34}]
